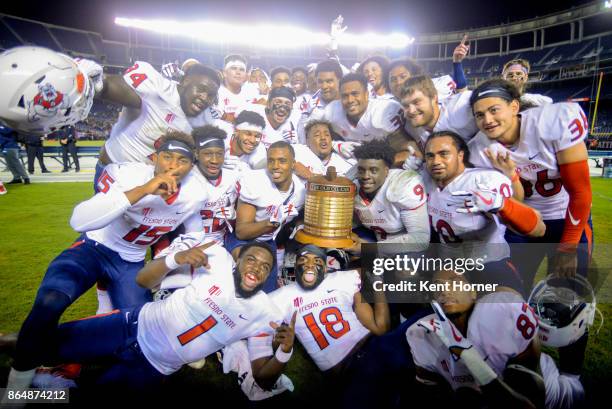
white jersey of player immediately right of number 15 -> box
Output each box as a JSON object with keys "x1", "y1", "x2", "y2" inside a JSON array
[{"x1": 194, "y1": 169, "x2": 240, "y2": 243}]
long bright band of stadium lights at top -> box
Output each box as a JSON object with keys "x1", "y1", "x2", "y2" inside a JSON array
[{"x1": 115, "y1": 17, "x2": 414, "y2": 48}]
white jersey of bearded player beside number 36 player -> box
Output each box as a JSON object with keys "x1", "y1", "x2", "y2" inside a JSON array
[{"x1": 404, "y1": 91, "x2": 478, "y2": 150}]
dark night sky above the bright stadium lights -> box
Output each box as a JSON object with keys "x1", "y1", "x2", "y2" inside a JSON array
[{"x1": 0, "y1": 0, "x2": 592, "y2": 39}]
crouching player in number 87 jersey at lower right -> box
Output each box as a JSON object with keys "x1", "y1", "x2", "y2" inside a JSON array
[{"x1": 406, "y1": 270, "x2": 584, "y2": 409}]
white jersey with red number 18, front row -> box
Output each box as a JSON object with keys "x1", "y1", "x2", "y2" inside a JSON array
[{"x1": 269, "y1": 270, "x2": 370, "y2": 371}]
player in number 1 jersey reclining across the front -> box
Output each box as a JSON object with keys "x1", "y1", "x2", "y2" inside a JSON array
[{"x1": 1, "y1": 241, "x2": 280, "y2": 391}]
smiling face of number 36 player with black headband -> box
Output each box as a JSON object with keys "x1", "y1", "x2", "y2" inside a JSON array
[{"x1": 472, "y1": 97, "x2": 520, "y2": 145}]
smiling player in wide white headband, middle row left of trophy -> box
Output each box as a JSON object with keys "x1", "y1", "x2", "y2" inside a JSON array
[{"x1": 223, "y1": 110, "x2": 266, "y2": 172}]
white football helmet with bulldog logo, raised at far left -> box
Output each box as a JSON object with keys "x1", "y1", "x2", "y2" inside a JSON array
[{"x1": 0, "y1": 46, "x2": 95, "y2": 134}]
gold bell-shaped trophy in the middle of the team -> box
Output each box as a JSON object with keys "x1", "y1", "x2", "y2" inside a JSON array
[{"x1": 295, "y1": 166, "x2": 356, "y2": 248}]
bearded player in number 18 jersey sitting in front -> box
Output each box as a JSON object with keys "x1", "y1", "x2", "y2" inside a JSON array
[{"x1": 253, "y1": 244, "x2": 428, "y2": 408}]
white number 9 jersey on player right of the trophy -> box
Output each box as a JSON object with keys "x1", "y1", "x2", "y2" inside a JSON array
[{"x1": 355, "y1": 169, "x2": 427, "y2": 241}]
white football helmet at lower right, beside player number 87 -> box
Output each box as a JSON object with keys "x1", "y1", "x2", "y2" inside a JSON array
[{"x1": 528, "y1": 275, "x2": 596, "y2": 348}]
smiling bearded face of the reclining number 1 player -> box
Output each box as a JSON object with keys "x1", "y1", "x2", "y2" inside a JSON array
[{"x1": 234, "y1": 246, "x2": 274, "y2": 298}]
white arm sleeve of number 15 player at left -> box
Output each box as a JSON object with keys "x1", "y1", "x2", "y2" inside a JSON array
[{"x1": 70, "y1": 164, "x2": 132, "y2": 232}]
